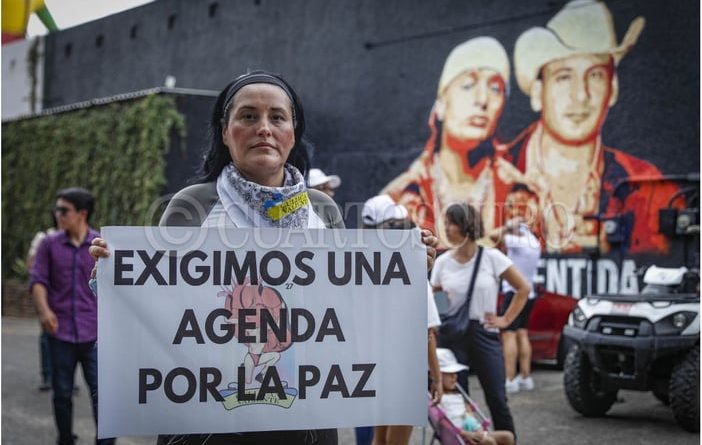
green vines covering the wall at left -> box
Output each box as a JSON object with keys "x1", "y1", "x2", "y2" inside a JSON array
[{"x1": 2, "y1": 95, "x2": 185, "y2": 277}]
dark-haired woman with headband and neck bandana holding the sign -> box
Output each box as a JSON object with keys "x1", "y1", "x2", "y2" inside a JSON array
[{"x1": 91, "y1": 71, "x2": 437, "y2": 445}]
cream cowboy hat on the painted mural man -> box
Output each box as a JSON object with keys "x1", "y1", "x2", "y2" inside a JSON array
[{"x1": 514, "y1": 0, "x2": 646, "y2": 95}]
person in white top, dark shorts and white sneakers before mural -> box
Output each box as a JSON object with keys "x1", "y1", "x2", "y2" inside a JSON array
[{"x1": 491, "y1": 184, "x2": 541, "y2": 393}]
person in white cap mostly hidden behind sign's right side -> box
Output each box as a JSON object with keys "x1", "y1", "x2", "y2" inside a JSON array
[{"x1": 366, "y1": 195, "x2": 442, "y2": 445}]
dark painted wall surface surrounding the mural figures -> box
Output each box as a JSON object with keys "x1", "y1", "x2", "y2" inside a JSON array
[{"x1": 44, "y1": 0, "x2": 700, "y2": 215}]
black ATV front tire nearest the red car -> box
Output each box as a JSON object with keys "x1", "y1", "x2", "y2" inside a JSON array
[{"x1": 563, "y1": 345, "x2": 617, "y2": 417}]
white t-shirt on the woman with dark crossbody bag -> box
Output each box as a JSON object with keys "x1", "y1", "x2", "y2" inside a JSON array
[{"x1": 431, "y1": 247, "x2": 512, "y2": 323}]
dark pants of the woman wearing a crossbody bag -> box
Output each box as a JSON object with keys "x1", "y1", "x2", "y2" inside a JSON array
[{"x1": 439, "y1": 320, "x2": 517, "y2": 438}]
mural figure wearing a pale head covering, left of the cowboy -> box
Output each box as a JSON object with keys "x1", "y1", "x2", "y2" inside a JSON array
[{"x1": 381, "y1": 37, "x2": 510, "y2": 247}]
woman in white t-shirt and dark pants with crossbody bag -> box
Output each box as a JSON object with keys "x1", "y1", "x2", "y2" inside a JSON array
[{"x1": 431, "y1": 204, "x2": 530, "y2": 436}]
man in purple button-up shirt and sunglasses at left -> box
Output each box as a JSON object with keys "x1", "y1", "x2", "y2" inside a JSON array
[{"x1": 29, "y1": 188, "x2": 115, "y2": 445}]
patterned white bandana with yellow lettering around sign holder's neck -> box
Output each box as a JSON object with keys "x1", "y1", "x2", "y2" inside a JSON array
[{"x1": 217, "y1": 163, "x2": 318, "y2": 229}]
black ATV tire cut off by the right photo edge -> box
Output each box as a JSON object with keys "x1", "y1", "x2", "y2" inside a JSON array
[{"x1": 669, "y1": 345, "x2": 700, "y2": 432}]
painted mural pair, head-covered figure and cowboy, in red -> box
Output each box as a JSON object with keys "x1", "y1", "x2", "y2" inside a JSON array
[{"x1": 383, "y1": 0, "x2": 677, "y2": 260}]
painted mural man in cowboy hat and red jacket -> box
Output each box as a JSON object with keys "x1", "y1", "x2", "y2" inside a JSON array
[{"x1": 498, "y1": 0, "x2": 675, "y2": 252}]
